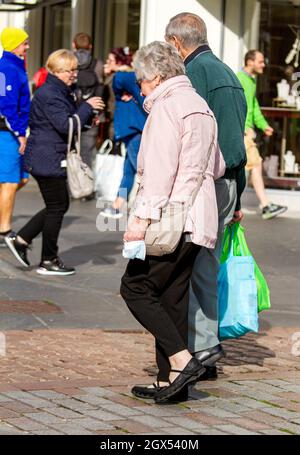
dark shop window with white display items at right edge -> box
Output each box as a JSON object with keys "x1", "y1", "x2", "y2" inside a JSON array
[{"x1": 258, "y1": 1, "x2": 300, "y2": 190}]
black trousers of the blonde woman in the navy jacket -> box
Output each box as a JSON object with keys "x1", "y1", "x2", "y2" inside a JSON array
[{"x1": 18, "y1": 177, "x2": 70, "y2": 261}]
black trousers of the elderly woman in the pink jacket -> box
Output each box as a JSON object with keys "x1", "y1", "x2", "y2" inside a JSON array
[{"x1": 121, "y1": 239, "x2": 200, "y2": 382}]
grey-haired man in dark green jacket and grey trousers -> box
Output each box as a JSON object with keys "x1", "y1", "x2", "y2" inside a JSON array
[{"x1": 165, "y1": 13, "x2": 247, "y2": 379}]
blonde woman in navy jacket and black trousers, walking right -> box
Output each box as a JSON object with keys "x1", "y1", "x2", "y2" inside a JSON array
[{"x1": 6, "y1": 49, "x2": 104, "y2": 276}]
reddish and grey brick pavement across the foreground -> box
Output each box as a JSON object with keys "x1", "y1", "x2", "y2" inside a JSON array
[{"x1": 0, "y1": 328, "x2": 300, "y2": 435}]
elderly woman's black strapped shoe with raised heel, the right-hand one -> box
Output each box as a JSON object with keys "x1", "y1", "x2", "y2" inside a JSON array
[{"x1": 154, "y1": 358, "x2": 205, "y2": 403}]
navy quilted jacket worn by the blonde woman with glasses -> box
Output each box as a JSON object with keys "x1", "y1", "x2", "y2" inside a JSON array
[{"x1": 25, "y1": 74, "x2": 93, "y2": 177}]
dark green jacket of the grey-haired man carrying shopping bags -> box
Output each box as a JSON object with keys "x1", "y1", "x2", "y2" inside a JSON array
[{"x1": 185, "y1": 46, "x2": 247, "y2": 210}]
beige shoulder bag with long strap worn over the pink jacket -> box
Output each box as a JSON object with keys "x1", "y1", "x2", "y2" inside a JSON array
[{"x1": 136, "y1": 118, "x2": 216, "y2": 256}]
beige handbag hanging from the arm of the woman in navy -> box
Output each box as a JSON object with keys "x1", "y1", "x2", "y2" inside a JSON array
[{"x1": 67, "y1": 115, "x2": 94, "y2": 199}]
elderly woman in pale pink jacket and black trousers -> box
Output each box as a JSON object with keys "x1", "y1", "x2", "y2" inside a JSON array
[{"x1": 121, "y1": 41, "x2": 225, "y2": 403}]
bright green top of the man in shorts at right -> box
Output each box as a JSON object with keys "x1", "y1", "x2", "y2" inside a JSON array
[{"x1": 237, "y1": 71, "x2": 269, "y2": 131}]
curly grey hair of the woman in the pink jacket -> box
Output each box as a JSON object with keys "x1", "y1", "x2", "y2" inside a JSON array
[{"x1": 133, "y1": 41, "x2": 185, "y2": 81}]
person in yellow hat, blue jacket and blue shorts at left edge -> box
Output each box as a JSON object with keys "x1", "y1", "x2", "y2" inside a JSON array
[{"x1": 0, "y1": 27, "x2": 30, "y2": 246}]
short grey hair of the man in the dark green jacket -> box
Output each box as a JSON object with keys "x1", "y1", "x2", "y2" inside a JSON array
[{"x1": 165, "y1": 13, "x2": 208, "y2": 49}]
